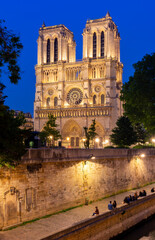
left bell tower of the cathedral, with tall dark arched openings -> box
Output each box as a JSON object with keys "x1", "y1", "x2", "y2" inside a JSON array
[{"x1": 37, "y1": 24, "x2": 76, "y2": 65}]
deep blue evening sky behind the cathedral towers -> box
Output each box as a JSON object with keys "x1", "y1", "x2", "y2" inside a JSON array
[{"x1": 0, "y1": 0, "x2": 155, "y2": 116}]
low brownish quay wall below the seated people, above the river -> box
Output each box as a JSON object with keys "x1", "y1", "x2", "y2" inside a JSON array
[{"x1": 42, "y1": 194, "x2": 155, "y2": 240}]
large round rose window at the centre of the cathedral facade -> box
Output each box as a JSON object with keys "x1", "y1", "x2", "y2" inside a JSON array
[{"x1": 67, "y1": 88, "x2": 83, "y2": 105}]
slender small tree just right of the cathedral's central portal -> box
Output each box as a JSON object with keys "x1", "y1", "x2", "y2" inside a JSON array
[{"x1": 84, "y1": 119, "x2": 97, "y2": 148}]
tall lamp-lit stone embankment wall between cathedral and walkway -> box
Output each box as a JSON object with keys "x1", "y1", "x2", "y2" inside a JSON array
[{"x1": 0, "y1": 148, "x2": 155, "y2": 229}]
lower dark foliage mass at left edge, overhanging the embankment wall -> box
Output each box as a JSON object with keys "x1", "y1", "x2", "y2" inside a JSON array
[{"x1": 0, "y1": 91, "x2": 29, "y2": 166}]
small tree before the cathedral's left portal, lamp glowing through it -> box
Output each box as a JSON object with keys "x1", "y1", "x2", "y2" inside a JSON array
[{"x1": 40, "y1": 114, "x2": 61, "y2": 146}]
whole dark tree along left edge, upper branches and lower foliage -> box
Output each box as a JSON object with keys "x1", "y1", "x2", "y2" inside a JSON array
[{"x1": 0, "y1": 21, "x2": 28, "y2": 166}]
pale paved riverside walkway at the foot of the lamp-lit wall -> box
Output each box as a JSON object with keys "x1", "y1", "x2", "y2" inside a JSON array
[{"x1": 0, "y1": 184, "x2": 155, "y2": 240}]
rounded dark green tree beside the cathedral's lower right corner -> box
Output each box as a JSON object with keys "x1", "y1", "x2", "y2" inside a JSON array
[{"x1": 110, "y1": 116, "x2": 137, "y2": 148}]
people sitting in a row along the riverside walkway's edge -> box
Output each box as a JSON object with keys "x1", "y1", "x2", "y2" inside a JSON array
[{"x1": 92, "y1": 187, "x2": 155, "y2": 216}]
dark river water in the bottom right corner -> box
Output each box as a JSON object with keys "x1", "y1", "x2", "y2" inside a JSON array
[{"x1": 111, "y1": 215, "x2": 155, "y2": 240}]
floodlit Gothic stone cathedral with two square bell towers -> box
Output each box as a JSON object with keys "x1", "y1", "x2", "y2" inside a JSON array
[{"x1": 34, "y1": 13, "x2": 123, "y2": 148}]
